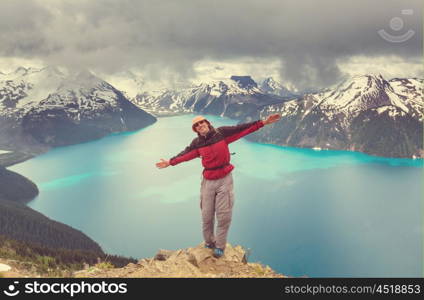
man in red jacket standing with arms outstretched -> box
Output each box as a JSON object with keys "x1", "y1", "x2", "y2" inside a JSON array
[{"x1": 156, "y1": 114, "x2": 281, "y2": 258}]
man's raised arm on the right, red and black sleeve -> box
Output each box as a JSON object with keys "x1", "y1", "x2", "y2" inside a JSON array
[{"x1": 218, "y1": 114, "x2": 281, "y2": 144}]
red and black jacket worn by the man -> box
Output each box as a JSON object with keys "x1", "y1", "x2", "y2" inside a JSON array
[{"x1": 170, "y1": 120, "x2": 264, "y2": 179}]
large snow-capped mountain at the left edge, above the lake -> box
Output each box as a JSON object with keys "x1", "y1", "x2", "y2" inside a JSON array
[{"x1": 0, "y1": 67, "x2": 156, "y2": 150}]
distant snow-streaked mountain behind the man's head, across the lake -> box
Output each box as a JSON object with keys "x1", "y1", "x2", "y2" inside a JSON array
[{"x1": 134, "y1": 76, "x2": 294, "y2": 118}]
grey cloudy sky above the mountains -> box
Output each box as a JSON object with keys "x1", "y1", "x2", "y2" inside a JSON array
[{"x1": 0, "y1": 0, "x2": 423, "y2": 89}]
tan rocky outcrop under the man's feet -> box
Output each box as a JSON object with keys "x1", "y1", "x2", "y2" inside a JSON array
[{"x1": 74, "y1": 243, "x2": 287, "y2": 278}]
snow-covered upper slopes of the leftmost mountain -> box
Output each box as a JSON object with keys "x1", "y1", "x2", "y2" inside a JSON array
[{"x1": 0, "y1": 67, "x2": 127, "y2": 118}]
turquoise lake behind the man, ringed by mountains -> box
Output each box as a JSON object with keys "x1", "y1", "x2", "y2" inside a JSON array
[{"x1": 9, "y1": 115, "x2": 423, "y2": 277}]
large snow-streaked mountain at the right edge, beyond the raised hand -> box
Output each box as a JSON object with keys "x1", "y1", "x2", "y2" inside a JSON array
[{"x1": 249, "y1": 74, "x2": 424, "y2": 158}]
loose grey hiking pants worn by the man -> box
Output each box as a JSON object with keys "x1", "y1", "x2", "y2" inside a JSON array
[{"x1": 200, "y1": 172, "x2": 234, "y2": 249}]
